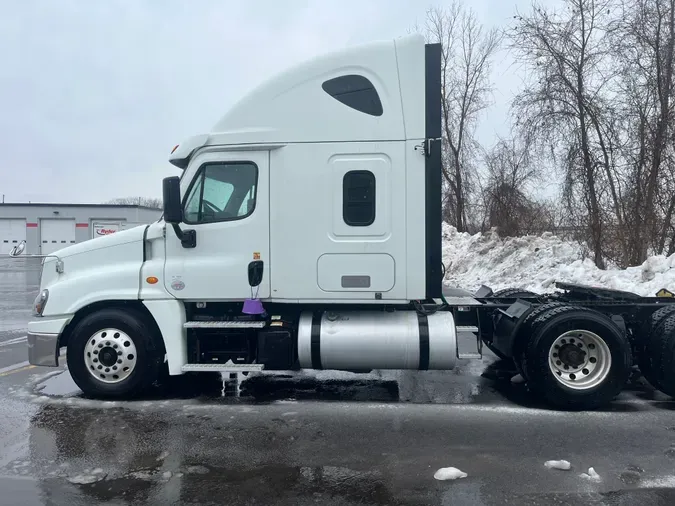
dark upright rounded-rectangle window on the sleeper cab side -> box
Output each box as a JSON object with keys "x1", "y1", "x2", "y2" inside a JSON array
[{"x1": 342, "y1": 170, "x2": 375, "y2": 227}]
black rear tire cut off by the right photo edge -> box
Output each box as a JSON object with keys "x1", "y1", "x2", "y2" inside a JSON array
[{"x1": 642, "y1": 311, "x2": 675, "y2": 397}]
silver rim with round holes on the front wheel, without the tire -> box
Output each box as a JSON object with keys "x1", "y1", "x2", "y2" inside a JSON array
[{"x1": 84, "y1": 328, "x2": 138, "y2": 384}]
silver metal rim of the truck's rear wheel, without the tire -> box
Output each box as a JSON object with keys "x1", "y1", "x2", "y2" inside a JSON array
[{"x1": 548, "y1": 330, "x2": 612, "y2": 390}]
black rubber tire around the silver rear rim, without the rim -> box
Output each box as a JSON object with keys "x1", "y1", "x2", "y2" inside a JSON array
[{"x1": 522, "y1": 306, "x2": 632, "y2": 409}]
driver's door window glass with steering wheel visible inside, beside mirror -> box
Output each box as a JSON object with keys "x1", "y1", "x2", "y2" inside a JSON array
[{"x1": 183, "y1": 162, "x2": 258, "y2": 224}]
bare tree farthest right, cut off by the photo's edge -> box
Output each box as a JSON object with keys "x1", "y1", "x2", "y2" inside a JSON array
[{"x1": 613, "y1": 0, "x2": 675, "y2": 264}]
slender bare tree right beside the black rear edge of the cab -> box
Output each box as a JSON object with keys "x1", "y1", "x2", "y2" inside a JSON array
[{"x1": 425, "y1": 2, "x2": 501, "y2": 231}]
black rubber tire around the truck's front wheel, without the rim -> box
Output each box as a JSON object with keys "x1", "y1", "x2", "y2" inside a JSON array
[{"x1": 67, "y1": 308, "x2": 163, "y2": 399}]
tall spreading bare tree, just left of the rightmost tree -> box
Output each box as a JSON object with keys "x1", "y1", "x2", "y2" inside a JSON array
[{"x1": 509, "y1": 0, "x2": 621, "y2": 268}]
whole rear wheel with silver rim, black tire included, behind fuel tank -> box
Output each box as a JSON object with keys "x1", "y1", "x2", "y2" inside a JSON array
[{"x1": 522, "y1": 306, "x2": 631, "y2": 409}]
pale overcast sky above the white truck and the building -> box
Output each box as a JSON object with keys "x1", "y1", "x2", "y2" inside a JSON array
[{"x1": 0, "y1": 0, "x2": 553, "y2": 203}]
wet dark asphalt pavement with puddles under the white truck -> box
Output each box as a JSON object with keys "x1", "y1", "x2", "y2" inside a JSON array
[{"x1": 0, "y1": 259, "x2": 675, "y2": 506}]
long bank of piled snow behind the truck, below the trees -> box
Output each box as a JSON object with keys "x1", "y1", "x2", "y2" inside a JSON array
[{"x1": 443, "y1": 224, "x2": 675, "y2": 296}]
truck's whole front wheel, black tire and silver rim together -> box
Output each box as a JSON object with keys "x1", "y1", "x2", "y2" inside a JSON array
[{"x1": 67, "y1": 308, "x2": 161, "y2": 399}]
